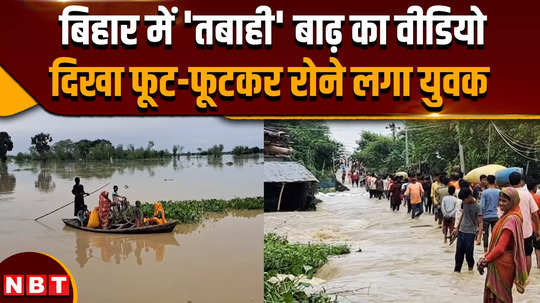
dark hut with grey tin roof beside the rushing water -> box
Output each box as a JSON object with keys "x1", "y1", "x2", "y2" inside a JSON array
[{"x1": 264, "y1": 161, "x2": 319, "y2": 212}]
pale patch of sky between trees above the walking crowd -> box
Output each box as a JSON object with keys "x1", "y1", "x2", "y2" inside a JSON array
[{"x1": 327, "y1": 120, "x2": 404, "y2": 152}]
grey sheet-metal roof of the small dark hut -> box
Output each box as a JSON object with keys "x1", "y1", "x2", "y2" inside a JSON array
[{"x1": 264, "y1": 161, "x2": 319, "y2": 183}]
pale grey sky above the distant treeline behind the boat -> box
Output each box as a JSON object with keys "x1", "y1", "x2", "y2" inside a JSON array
[{"x1": 0, "y1": 107, "x2": 263, "y2": 155}]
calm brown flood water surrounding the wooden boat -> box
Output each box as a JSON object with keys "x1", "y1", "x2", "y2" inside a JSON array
[{"x1": 0, "y1": 155, "x2": 263, "y2": 303}]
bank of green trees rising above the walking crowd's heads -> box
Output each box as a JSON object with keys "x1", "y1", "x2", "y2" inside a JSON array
[{"x1": 353, "y1": 120, "x2": 540, "y2": 175}]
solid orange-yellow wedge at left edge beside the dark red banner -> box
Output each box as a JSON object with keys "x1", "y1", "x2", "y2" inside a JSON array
[{"x1": 0, "y1": 67, "x2": 37, "y2": 117}]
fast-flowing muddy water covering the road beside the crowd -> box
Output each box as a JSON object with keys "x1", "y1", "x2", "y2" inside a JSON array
[{"x1": 264, "y1": 189, "x2": 540, "y2": 302}]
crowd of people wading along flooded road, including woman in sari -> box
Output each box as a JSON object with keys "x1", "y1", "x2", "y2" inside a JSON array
[{"x1": 350, "y1": 166, "x2": 540, "y2": 302}]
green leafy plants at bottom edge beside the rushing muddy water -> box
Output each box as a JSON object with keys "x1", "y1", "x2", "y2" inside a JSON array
[{"x1": 264, "y1": 233, "x2": 350, "y2": 303}]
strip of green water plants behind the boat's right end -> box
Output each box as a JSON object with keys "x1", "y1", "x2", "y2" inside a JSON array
[{"x1": 141, "y1": 197, "x2": 264, "y2": 223}]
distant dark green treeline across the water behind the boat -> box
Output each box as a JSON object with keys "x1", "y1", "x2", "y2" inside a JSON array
[{"x1": 0, "y1": 132, "x2": 262, "y2": 161}]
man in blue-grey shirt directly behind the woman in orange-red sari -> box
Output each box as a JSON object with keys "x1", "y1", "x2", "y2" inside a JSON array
[{"x1": 480, "y1": 175, "x2": 500, "y2": 252}]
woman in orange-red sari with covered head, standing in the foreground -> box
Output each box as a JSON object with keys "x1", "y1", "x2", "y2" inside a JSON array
[{"x1": 478, "y1": 187, "x2": 528, "y2": 303}]
